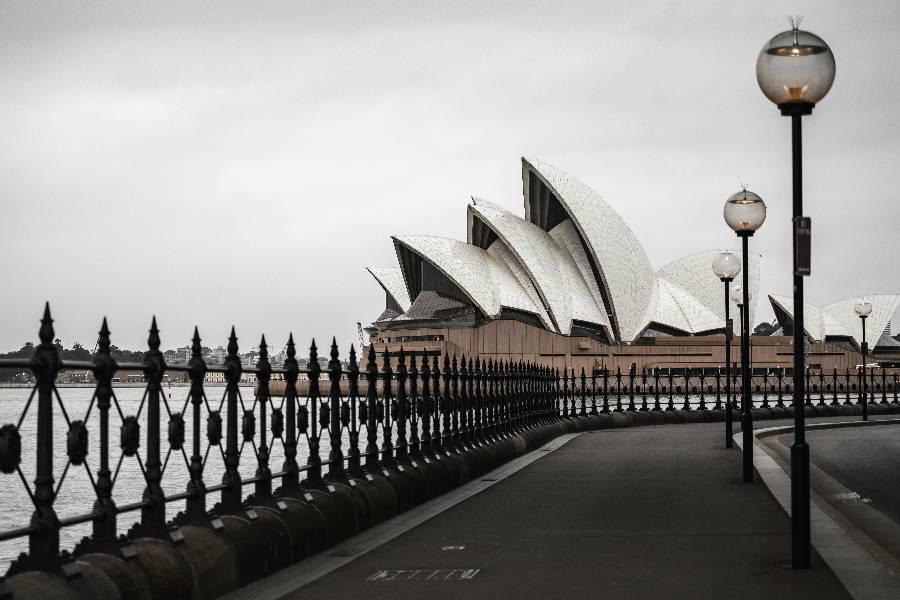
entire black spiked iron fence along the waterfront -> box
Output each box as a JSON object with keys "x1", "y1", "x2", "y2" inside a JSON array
[{"x1": 0, "y1": 307, "x2": 898, "y2": 595}]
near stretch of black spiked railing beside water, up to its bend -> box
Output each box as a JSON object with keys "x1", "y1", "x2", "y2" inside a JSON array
[{"x1": 0, "y1": 307, "x2": 558, "y2": 576}]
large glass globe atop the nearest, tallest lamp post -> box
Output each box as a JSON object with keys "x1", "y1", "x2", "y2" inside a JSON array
[{"x1": 756, "y1": 23, "x2": 835, "y2": 114}]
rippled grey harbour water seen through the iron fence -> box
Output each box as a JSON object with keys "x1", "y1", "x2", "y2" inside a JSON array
[{"x1": 0, "y1": 386, "x2": 330, "y2": 573}]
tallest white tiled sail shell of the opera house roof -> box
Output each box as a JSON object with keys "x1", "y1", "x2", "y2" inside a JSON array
[{"x1": 522, "y1": 157, "x2": 657, "y2": 341}]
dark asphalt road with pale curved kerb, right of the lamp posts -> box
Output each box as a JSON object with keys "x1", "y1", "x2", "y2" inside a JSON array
[{"x1": 739, "y1": 415, "x2": 900, "y2": 600}]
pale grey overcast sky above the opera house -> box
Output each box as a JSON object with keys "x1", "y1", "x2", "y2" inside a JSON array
[{"x1": 0, "y1": 0, "x2": 900, "y2": 351}]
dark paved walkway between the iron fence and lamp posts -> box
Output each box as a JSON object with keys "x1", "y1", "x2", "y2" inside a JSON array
[{"x1": 276, "y1": 423, "x2": 849, "y2": 600}]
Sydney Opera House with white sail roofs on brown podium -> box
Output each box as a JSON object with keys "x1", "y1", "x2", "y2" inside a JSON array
[{"x1": 367, "y1": 158, "x2": 892, "y2": 370}]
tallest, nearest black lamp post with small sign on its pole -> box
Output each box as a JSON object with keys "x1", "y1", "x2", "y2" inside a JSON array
[{"x1": 756, "y1": 18, "x2": 835, "y2": 569}]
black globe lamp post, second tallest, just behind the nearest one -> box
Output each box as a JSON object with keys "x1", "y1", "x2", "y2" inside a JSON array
[{"x1": 723, "y1": 188, "x2": 766, "y2": 483}]
